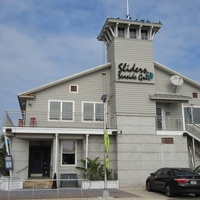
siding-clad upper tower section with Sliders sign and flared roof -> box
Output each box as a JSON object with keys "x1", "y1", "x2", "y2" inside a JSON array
[{"x1": 97, "y1": 17, "x2": 162, "y2": 119}]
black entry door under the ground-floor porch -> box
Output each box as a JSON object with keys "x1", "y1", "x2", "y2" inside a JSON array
[{"x1": 29, "y1": 146, "x2": 50, "y2": 177}]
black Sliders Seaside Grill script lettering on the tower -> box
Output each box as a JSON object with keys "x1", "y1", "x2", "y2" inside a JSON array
[{"x1": 118, "y1": 63, "x2": 153, "y2": 81}]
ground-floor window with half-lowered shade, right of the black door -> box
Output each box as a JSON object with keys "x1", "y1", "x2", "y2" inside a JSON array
[{"x1": 61, "y1": 140, "x2": 76, "y2": 165}]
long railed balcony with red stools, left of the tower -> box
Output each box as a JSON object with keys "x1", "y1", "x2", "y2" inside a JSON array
[{"x1": 3, "y1": 111, "x2": 116, "y2": 129}]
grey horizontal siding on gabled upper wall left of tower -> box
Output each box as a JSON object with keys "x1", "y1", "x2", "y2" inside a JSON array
[{"x1": 27, "y1": 69, "x2": 110, "y2": 128}]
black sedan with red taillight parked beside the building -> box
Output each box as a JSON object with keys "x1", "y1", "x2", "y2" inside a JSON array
[{"x1": 146, "y1": 168, "x2": 200, "y2": 197}]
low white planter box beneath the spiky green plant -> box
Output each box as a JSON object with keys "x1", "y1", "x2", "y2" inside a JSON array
[{"x1": 81, "y1": 180, "x2": 119, "y2": 189}]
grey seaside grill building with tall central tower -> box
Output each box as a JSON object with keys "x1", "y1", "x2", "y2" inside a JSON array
[{"x1": 3, "y1": 18, "x2": 200, "y2": 187}]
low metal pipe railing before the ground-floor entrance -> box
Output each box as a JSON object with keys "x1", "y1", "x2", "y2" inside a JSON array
[{"x1": 0, "y1": 177, "x2": 93, "y2": 200}]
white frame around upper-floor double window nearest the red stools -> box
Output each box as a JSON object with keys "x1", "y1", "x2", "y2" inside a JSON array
[{"x1": 48, "y1": 100, "x2": 75, "y2": 122}]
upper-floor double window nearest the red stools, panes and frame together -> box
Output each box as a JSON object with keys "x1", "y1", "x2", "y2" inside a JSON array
[{"x1": 49, "y1": 101, "x2": 74, "y2": 121}]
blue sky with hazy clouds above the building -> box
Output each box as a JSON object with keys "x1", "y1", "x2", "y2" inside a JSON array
[{"x1": 0, "y1": 0, "x2": 200, "y2": 126}]
